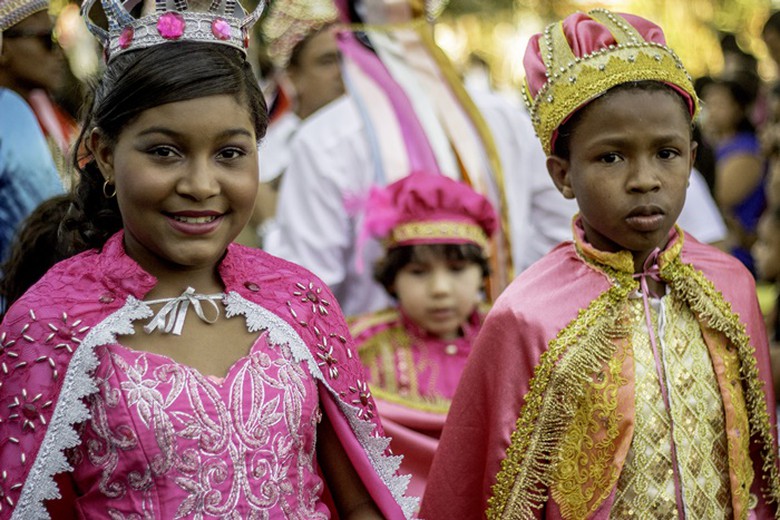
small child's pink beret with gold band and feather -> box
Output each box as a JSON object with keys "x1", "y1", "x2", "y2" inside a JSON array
[{"x1": 364, "y1": 173, "x2": 498, "y2": 248}]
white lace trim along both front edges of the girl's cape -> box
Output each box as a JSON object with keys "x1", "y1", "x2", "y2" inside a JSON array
[{"x1": 12, "y1": 292, "x2": 418, "y2": 520}]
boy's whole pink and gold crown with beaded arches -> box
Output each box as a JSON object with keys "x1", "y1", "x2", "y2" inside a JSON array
[{"x1": 523, "y1": 9, "x2": 698, "y2": 155}]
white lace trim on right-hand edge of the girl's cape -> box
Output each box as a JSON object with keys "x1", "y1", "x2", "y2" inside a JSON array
[{"x1": 225, "y1": 292, "x2": 419, "y2": 518}]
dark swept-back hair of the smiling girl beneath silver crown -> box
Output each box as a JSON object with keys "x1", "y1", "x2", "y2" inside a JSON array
[{"x1": 63, "y1": 42, "x2": 268, "y2": 255}]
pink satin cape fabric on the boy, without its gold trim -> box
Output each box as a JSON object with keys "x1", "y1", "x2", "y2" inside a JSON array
[{"x1": 420, "y1": 225, "x2": 777, "y2": 520}]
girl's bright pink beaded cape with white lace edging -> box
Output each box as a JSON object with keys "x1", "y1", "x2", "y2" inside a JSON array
[{"x1": 0, "y1": 232, "x2": 417, "y2": 518}]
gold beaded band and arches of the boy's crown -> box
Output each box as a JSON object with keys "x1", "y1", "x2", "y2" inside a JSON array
[{"x1": 523, "y1": 10, "x2": 699, "y2": 155}]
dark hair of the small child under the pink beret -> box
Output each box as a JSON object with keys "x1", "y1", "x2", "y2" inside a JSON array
[{"x1": 374, "y1": 244, "x2": 490, "y2": 298}]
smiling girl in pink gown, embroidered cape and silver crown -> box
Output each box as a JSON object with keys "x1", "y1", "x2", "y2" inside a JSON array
[{"x1": 0, "y1": 1, "x2": 416, "y2": 519}]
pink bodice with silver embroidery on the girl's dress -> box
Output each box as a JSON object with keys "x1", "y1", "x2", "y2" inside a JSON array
[{"x1": 75, "y1": 334, "x2": 327, "y2": 519}]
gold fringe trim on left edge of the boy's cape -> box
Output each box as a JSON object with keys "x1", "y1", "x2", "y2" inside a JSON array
[{"x1": 486, "y1": 268, "x2": 639, "y2": 519}]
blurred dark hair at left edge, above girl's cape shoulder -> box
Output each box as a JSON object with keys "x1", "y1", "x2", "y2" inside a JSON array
[{"x1": 0, "y1": 194, "x2": 71, "y2": 317}]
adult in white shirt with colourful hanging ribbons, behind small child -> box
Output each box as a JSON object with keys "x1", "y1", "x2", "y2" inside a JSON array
[{"x1": 268, "y1": 0, "x2": 725, "y2": 314}]
